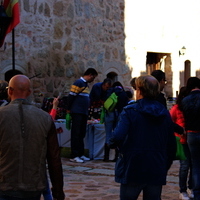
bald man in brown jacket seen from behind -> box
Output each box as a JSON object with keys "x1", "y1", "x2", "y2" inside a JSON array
[{"x1": 0, "y1": 75, "x2": 64, "y2": 200}]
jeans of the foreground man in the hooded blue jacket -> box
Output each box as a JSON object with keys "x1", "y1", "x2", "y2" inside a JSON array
[{"x1": 120, "y1": 183, "x2": 162, "y2": 200}]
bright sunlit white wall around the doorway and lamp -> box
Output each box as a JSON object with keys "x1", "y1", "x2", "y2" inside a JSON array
[{"x1": 125, "y1": 0, "x2": 200, "y2": 95}]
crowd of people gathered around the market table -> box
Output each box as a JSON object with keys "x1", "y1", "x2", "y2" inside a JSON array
[{"x1": 0, "y1": 68, "x2": 200, "y2": 200}]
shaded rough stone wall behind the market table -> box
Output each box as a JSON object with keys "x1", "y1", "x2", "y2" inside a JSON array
[{"x1": 0, "y1": 0, "x2": 131, "y2": 101}]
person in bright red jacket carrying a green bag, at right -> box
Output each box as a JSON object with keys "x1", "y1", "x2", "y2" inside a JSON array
[{"x1": 170, "y1": 87, "x2": 194, "y2": 200}]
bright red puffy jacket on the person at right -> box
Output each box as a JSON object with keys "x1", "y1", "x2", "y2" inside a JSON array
[{"x1": 169, "y1": 104, "x2": 187, "y2": 144}]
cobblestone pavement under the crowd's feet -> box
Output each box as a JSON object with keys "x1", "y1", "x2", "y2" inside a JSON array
[{"x1": 51, "y1": 158, "x2": 184, "y2": 200}]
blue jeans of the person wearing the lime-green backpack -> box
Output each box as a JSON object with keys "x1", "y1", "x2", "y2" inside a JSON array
[{"x1": 104, "y1": 111, "x2": 119, "y2": 144}]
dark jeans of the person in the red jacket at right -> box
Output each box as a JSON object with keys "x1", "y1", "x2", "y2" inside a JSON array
[{"x1": 179, "y1": 144, "x2": 193, "y2": 193}]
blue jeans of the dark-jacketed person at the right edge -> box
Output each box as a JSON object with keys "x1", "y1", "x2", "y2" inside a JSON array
[{"x1": 187, "y1": 132, "x2": 200, "y2": 200}]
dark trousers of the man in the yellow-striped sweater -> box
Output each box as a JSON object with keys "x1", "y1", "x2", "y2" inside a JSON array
[{"x1": 71, "y1": 113, "x2": 87, "y2": 158}]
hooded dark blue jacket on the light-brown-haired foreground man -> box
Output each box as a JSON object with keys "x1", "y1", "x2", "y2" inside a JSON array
[{"x1": 109, "y1": 98, "x2": 176, "y2": 185}]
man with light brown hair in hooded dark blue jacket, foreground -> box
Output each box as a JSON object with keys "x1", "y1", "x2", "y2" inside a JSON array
[{"x1": 109, "y1": 75, "x2": 176, "y2": 200}]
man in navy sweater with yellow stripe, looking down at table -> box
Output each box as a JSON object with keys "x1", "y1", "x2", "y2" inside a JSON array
[{"x1": 67, "y1": 68, "x2": 98, "y2": 163}]
